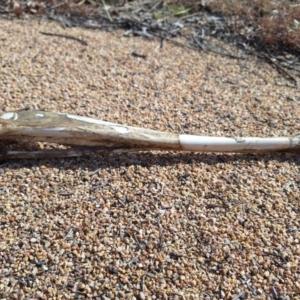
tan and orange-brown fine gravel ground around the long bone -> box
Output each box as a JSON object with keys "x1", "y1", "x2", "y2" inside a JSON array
[{"x1": 0, "y1": 20, "x2": 300, "y2": 300}]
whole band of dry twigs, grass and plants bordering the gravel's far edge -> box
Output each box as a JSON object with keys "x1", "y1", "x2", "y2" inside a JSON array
[{"x1": 2, "y1": 0, "x2": 300, "y2": 87}]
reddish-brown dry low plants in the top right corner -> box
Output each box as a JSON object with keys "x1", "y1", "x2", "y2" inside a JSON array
[{"x1": 172, "y1": 0, "x2": 300, "y2": 53}]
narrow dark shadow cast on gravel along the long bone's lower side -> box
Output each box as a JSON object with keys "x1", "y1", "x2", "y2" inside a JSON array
[{"x1": 0, "y1": 152, "x2": 300, "y2": 172}]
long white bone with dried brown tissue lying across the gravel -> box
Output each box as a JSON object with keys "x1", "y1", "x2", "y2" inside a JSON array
[{"x1": 0, "y1": 110, "x2": 300, "y2": 158}]
